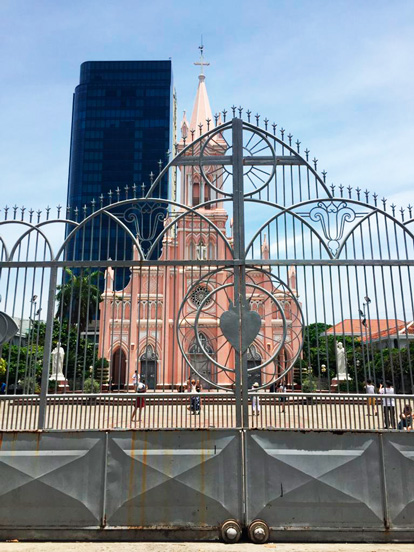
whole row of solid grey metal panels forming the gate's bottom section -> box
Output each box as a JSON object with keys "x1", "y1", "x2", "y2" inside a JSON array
[{"x1": 0, "y1": 430, "x2": 414, "y2": 541}]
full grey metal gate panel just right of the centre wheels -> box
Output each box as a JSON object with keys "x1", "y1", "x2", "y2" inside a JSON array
[{"x1": 246, "y1": 431, "x2": 384, "y2": 530}]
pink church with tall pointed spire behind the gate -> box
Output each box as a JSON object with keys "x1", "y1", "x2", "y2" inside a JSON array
[{"x1": 99, "y1": 67, "x2": 301, "y2": 390}]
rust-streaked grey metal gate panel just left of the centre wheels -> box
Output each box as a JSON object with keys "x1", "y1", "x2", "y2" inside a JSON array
[{"x1": 106, "y1": 430, "x2": 242, "y2": 529}]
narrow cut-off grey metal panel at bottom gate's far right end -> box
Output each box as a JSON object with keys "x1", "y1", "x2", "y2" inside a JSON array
[{"x1": 382, "y1": 431, "x2": 414, "y2": 530}]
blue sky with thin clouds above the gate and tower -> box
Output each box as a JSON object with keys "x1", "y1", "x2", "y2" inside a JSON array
[{"x1": 0, "y1": 0, "x2": 414, "y2": 212}]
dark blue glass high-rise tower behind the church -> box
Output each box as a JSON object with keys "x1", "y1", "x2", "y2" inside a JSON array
[{"x1": 67, "y1": 61, "x2": 173, "y2": 282}]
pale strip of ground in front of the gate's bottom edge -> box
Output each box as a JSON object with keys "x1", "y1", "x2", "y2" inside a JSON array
[{"x1": 0, "y1": 542, "x2": 414, "y2": 552}]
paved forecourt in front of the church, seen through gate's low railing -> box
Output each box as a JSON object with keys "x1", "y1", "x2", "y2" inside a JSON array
[{"x1": 0, "y1": 394, "x2": 406, "y2": 431}]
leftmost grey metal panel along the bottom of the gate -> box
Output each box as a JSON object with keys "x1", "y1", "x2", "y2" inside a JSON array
[{"x1": 0, "y1": 432, "x2": 105, "y2": 529}]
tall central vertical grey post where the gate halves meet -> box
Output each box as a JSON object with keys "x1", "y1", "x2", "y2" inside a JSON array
[{"x1": 232, "y1": 118, "x2": 249, "y2": 427}]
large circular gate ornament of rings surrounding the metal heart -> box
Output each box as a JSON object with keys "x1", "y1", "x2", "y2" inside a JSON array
[{"x1": 177, "y1": 268, "x2": 302, "y2": 389}]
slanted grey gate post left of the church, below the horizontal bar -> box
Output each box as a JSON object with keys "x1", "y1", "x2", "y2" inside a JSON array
[{"x1": 37, "y1": 266, "x2": 57, "y2": 429}]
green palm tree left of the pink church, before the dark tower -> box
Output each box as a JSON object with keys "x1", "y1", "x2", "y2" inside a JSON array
[{"x1": 56, "y1": 268, "x2": 102, "y2": 331}]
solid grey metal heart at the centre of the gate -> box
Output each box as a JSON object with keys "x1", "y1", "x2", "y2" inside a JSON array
[{"x1": 220, "y1": 299, "x2": 262, "y2": 353}]
